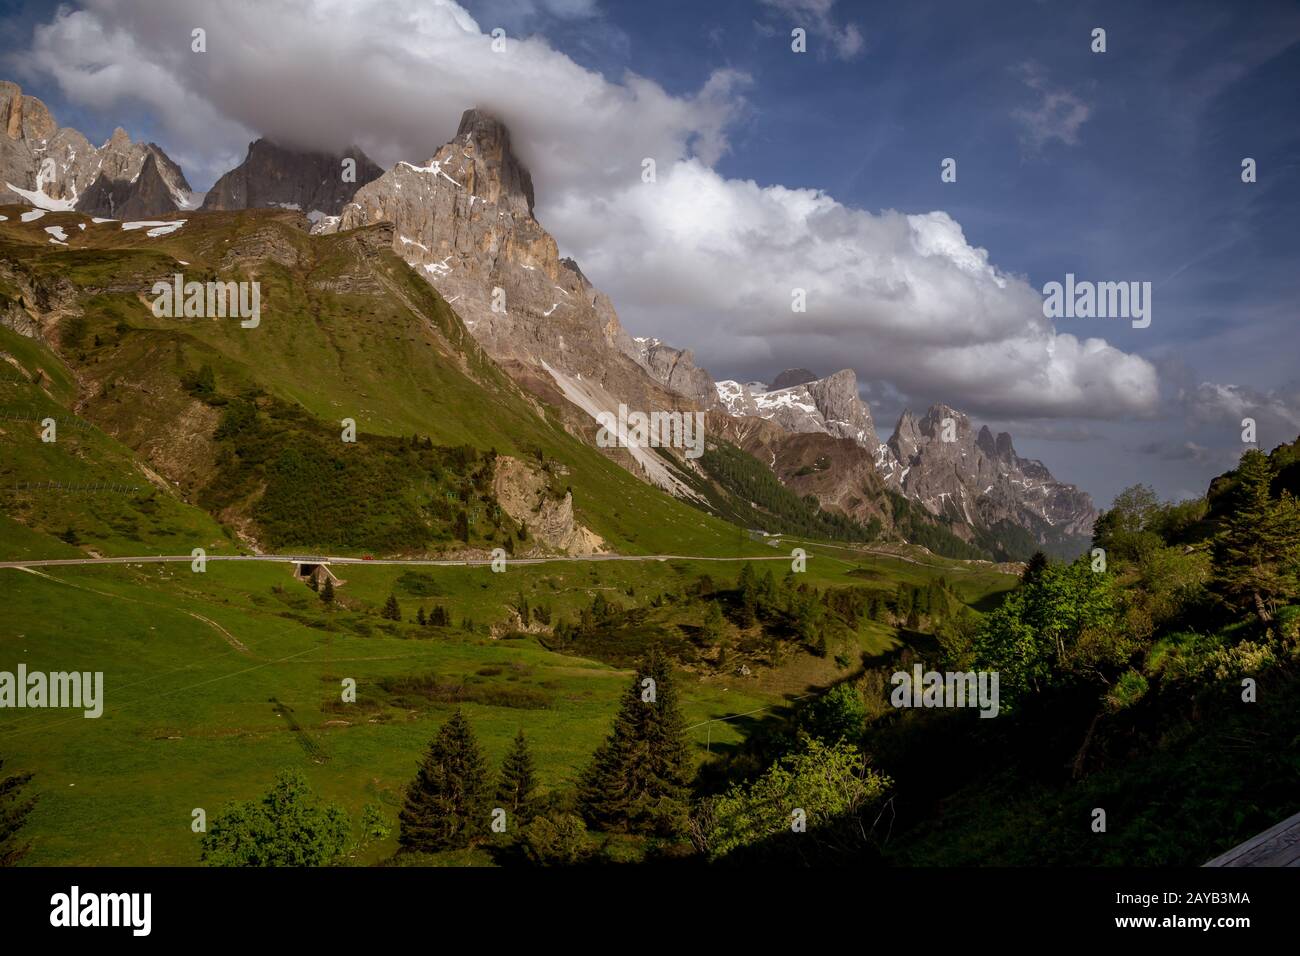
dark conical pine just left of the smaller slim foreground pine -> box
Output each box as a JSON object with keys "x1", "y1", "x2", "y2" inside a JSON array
[{"x1": 398, "y1": 710, "x2": 490, "y2": 852}]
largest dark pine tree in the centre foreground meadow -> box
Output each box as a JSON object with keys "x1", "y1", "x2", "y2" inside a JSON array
[{"x1": 579, "y1": 654, "x2": 690, "y2": 836}]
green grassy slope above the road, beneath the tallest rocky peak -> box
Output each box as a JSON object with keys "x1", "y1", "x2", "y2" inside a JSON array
[{"x1": 0, "y1": 208, "x2": 764, "y2": 554}]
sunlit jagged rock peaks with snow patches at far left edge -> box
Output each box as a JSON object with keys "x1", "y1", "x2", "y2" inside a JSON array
[{"x1": 0, "y1": 82, "x2": 192, "y2": 219}]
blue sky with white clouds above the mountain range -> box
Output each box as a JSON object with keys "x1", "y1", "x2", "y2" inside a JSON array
[{"x1": 0, "y1": 0, "x2": 1300, "y2": 505}]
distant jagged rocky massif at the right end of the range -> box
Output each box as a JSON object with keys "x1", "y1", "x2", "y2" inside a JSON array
[{"x1": 876, "y1": 405, "x2": 1097, "y2": 544}]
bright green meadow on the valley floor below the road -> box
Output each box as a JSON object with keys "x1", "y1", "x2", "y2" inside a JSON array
[{"x1": 0, "y1": 538, "x2": 1013, "y2": 865}]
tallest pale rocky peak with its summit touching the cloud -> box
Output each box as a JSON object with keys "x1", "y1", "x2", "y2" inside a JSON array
[{"x1": 317, "y1": 109, "x2": 692, "y2": 421}]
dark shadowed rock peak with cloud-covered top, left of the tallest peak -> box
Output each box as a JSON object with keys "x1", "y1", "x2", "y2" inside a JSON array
[{"x1": 203, "y1": 139, "x2": 384, "y2": 221}]
